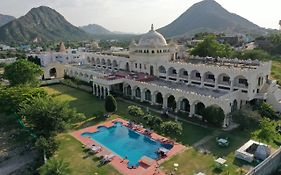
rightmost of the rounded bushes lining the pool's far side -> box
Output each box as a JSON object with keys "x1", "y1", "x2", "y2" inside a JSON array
[{"x1": 160, "y1": 121, "x2": 182, "y2": 135}]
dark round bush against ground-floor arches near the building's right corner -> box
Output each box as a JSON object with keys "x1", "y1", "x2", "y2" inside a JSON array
[{"x1": 203, "y1": 105, "x2": 225, "y2": 127}]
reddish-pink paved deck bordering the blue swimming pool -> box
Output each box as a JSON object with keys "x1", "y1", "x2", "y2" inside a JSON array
[{"x1": 71, "y1": 118, "x2": 186, "y2": 175}]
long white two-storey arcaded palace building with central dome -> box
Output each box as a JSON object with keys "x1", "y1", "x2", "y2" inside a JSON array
[{"x1": 38, "y1": 26, "x2": 281, "y2": 126}]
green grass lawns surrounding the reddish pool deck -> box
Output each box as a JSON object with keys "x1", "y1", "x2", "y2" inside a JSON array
[{"x1": 44, "y1": 85, "x2": 249, "y2": 174}]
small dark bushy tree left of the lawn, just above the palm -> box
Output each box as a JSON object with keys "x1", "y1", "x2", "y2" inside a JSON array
[{"x1": 35, "y1": 136, "x2": 58, "y2": 158}]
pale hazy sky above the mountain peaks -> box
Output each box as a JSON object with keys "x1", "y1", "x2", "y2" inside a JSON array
[{"x1": 0, "y1": 0, "x2": 281, "y2": 33}]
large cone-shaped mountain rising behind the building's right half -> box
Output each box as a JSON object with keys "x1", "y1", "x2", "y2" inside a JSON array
[{"x1": 158, "y1": 0, "x2": 266, "y2": 37}]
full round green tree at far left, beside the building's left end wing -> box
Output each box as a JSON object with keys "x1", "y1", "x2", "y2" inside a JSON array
[{"x1": 4, "y1": 59, "x2": 43, "y2": 86}]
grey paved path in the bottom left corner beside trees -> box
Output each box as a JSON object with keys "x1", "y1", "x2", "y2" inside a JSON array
[{"x1": 0, "y1": 152, "x2": 36, "y2": 175}]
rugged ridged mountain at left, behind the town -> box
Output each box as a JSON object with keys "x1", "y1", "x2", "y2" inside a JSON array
[{"x1": 0, "y1": 6, "x2": 89, "y2": 42}]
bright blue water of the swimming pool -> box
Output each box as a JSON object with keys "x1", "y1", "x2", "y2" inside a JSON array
[{"x1": 82, "y1": 122, "x2": 173, "y2": 166}]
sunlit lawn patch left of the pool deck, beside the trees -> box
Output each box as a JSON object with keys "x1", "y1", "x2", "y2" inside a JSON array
[{"x1": 55, "y1": 134, "x2": 120, "y2": 175}]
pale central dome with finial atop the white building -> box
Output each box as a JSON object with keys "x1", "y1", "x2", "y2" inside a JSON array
[{"x1": 138, "y1": 25, "x2": 167, "y2": 47}]
